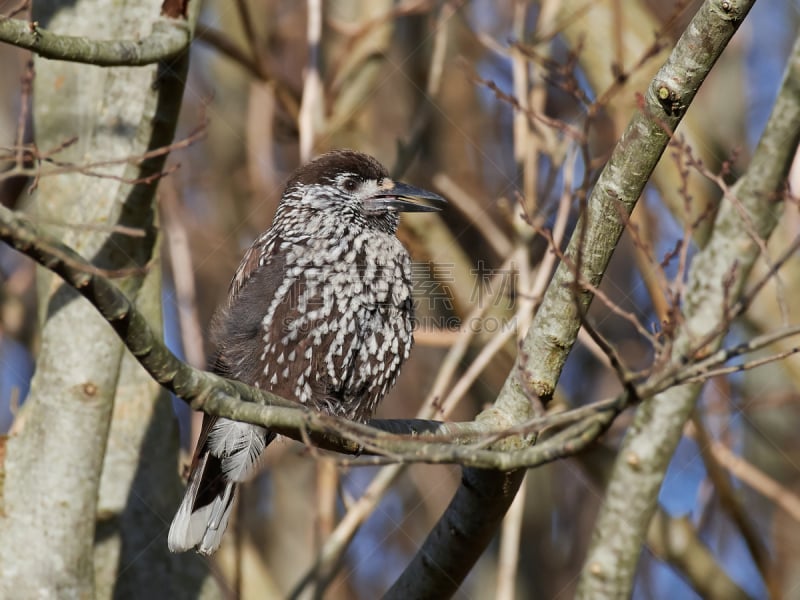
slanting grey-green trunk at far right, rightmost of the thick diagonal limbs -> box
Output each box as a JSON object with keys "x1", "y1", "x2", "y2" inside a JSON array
[{"x1": 578, "y1": 21, "x2": 800, "y2": 598}]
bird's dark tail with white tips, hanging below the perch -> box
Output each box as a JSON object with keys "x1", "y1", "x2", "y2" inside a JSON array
[{"x1": 167, "y1": 419, "x2": 271, "y2": 554}]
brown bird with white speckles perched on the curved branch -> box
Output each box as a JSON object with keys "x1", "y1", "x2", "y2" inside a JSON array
[{"x1": 167, "y1": 149, "x2": 446, "y2": 555}]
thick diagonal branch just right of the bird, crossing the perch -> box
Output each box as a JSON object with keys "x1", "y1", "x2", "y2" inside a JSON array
[{"x1": 388, "y1": 0, "x2": 754, "y2": 598}]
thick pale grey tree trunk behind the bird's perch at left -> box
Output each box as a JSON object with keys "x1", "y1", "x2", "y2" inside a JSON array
[{"x1": 0, "y1": 0, "x2": 213, "y2": 598}]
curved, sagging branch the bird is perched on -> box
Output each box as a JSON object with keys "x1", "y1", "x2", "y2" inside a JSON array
[{"x1": 0, "y1": 202, "x2": 627, "y2": 470}]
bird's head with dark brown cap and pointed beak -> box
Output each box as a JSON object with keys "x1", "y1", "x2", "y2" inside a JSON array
[{"x1": 278, "y1": 150, "x2": 445, "y2": 234}]
